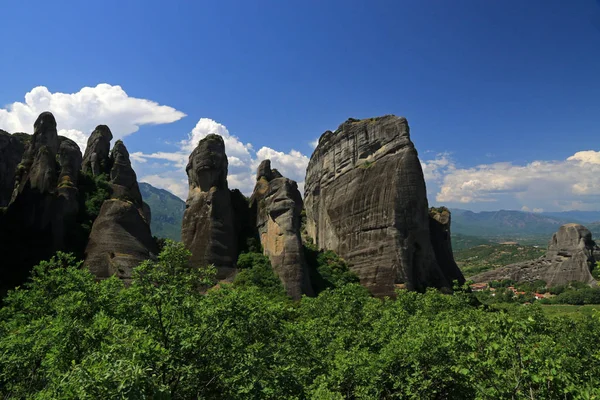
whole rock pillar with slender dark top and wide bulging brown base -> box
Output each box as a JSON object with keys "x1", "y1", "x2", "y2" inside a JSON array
[{"x1": 84, "y1": 139, "x2": 158, "y2": 282}]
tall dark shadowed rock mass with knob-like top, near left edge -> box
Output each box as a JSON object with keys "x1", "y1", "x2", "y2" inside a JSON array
[{"x1": 0, "y1": 112, "x2": 81, "y2": 289}]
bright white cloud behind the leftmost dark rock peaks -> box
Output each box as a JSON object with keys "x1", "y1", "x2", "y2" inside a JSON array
[{"x1": 0, "y1": 83, "x2": 185, "y2": 151}]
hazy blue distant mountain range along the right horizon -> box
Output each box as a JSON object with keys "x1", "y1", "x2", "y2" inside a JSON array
[{"x1": 451, "y1": 209, "x2": 600, "y2": 245}]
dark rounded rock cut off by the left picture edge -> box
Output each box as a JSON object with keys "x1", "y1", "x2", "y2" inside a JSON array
[{"x1": 0, "y1": 130, "x2": 25, "y2": 207}]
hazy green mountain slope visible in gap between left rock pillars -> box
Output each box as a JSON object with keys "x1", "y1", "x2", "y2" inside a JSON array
[{"x1": 139, "y1": 182, "x2": 185, "y2": 241}]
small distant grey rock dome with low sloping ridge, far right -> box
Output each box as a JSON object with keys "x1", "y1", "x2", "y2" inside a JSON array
[{"x1": 470, "y1": 224, "x2": 599, "y2": 287}]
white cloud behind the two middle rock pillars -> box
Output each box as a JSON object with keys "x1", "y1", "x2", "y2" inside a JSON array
[{"x1": 137, "y1": 118, "x2": 308, "y2": 198}]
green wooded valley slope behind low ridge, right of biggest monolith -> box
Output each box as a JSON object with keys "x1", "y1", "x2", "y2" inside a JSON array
[{"x1": 454, "y1": 244, "x2": 546, "y2": 277}]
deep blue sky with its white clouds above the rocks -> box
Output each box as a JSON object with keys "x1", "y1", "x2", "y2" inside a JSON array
[{"x1": 0, "y1": 0, "x2": 600, "y2": 211}]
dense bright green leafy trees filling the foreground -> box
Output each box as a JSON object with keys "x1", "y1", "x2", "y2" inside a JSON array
[{"x1": 0, "y1": 242, "x2": 600, "y2": 399}]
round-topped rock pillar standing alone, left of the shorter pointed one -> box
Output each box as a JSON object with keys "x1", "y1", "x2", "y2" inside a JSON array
[{"x1": 181, "y1": 134, "x2": 237, "y2": 279}]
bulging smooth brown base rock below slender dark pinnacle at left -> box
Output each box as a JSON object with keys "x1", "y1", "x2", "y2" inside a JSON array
[{"x1": 84, "y1": 199, "x2": 158, "y2": 282}]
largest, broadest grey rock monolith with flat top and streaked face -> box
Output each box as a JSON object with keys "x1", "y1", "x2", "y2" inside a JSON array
[{"x1": 304, "y1": 115, "x2": 464, "y2": 296}]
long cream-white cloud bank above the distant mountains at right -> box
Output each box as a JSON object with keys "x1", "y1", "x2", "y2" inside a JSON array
[{"x1": 422, "y1": 150, "x2": 600, "y2": 212}]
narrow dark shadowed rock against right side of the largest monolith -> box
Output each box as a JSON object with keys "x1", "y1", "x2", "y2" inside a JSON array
[{"x1": 429, "y1": 207, "x2": 465, "y2": 285}]
